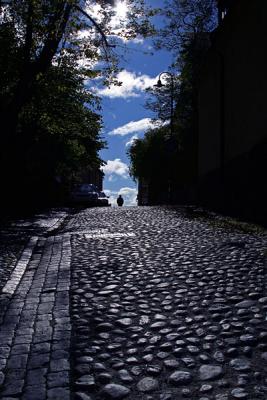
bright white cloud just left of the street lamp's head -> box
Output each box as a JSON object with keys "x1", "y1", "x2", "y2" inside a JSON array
[{"x1": 95, "y1": 70, "x2": 156, "y2": 99}]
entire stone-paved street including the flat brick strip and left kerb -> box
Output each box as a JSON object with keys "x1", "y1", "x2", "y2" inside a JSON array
[{"x1": 0, "y1": 207, "x2": 267, "y2": 400}]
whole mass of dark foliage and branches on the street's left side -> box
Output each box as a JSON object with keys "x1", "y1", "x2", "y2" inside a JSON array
[{"x1": 0, "y1": 0, "x2": 156, "y2": 206}]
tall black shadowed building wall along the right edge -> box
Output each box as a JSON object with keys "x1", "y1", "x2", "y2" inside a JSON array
[{"x1": 198, "y1": 0, "x2": 267, "y2": 223}]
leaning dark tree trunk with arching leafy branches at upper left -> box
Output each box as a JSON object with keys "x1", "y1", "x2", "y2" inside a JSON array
[{"x1": 0, "y1": 0, "x2": 154, "y2": 137}]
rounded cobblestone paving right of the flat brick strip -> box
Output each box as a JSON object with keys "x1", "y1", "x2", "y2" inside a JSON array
[{"x1": 69, "y1": 207, "x2": 267, "y2": 400}]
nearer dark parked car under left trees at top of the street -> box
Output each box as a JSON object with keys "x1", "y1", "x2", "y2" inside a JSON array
[{"x1": 70, "y1": 183, "x2": 98, "y2": 206}]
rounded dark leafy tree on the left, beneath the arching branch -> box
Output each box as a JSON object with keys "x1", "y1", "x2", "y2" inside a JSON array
[{"x1": 1, "y1": 52, "x2": 105, "y2": 206}]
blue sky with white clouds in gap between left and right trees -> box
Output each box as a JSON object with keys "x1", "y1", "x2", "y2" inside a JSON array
[{"x1": 87, "y1": 0, "x2": 172, "y2": 205}]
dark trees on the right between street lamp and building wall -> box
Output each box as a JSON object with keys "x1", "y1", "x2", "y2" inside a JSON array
[{"x1": 129, "y1": 0, "x2": 217, "y2": 205}]
